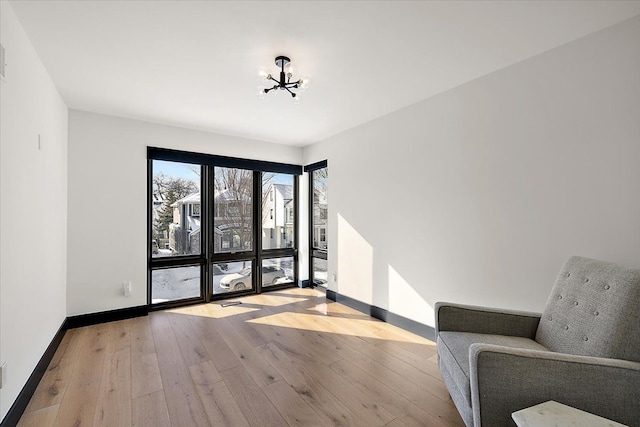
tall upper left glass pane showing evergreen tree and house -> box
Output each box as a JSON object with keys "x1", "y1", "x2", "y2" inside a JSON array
[{"x1": 151, "y1": 160, "x2": 202, "y2": 258}]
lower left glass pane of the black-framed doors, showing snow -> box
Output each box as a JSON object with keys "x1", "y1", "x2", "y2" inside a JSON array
[{"x1": 151, "y1": 266, "x2": 201, "y2": 304}]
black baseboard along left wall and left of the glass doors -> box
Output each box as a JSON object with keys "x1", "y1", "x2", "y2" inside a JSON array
[{"x1": 0, "y1": 305, "x2": 149, "y2": 427}]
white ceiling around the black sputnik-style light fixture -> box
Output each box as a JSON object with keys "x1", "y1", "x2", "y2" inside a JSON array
[{"x1": 7, "y1": 0, "x2": 640, "y2": 146}]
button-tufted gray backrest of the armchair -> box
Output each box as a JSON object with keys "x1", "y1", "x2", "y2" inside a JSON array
[{"x1": 536, "y1": 257, "x2": 640, "y2": 362}]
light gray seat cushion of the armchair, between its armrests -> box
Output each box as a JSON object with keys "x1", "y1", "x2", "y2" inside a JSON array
[{"x1": 437, "y1": 332, "x2": 546, "y2": 406}]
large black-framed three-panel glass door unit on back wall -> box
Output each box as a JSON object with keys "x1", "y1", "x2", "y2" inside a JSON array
[{"x1": 148, "y1": 148, "x2": 302, "y2": 307}]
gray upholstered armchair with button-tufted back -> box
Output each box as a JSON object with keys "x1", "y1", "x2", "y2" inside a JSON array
[{"x1": 435, "y1": 257, "x2": 640, "y2": 427}]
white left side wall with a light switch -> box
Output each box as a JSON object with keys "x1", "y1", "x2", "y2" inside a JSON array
[{"x1": 0, "y1": 1, "x2": 67, "y2": 419}]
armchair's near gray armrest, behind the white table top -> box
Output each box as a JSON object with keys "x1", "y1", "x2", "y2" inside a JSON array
[{"x1": 469, "y1": 344, "x2": 640, "y2": 426}]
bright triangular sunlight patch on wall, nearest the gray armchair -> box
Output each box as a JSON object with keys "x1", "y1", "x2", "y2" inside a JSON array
[{"x1": 389, "y1": 266, "x2": 435, "y2": 326}]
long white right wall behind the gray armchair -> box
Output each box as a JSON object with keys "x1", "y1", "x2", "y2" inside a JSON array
[{"x1": 304, "y1": 14, "x2": 640, "y2": 326}]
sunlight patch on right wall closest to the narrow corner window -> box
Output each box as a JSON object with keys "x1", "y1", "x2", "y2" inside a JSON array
[{"x1": 336, "y1": 214, "x2": 373, "y2": 304}]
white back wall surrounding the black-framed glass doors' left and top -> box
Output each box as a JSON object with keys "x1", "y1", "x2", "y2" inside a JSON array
[{"x1": 67, "y1": 110, "x2": 302, "y2": 316}]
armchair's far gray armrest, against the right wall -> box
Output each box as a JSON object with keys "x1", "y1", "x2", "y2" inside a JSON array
[{"x1": 435, "y1": 302, "x2": 541, "y2": 339}]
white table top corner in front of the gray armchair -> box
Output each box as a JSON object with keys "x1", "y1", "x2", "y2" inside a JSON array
[{"x1": 511, "y1": 400, "x2": 628, "y2": 427}]
